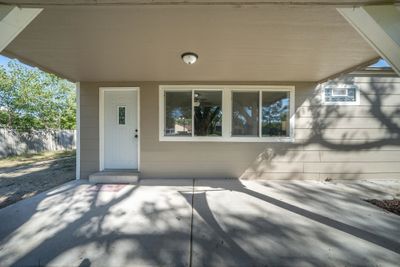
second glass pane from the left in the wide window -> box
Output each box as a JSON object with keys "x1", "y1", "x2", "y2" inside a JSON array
[{"x1": 194, "y1": 91, "x2": 222, "y2": 136}]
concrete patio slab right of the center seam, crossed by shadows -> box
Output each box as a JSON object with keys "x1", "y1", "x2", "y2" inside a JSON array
[{"x1": 192, "y1": 180, "x2": 400, "y2": 266}]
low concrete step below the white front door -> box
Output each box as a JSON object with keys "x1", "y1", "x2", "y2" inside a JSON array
[{"x1": 89, "y1": 170, "x2": 140, "y2": 184}]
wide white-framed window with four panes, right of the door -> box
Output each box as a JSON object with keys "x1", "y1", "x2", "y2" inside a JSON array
[{"x1": 159, "y1": 85, "x2": 294, "y2": 142}]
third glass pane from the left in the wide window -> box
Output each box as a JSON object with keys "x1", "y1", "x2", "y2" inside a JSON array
[{"x1": 232, "y1": 92, "x2": 259, "y2": 136}]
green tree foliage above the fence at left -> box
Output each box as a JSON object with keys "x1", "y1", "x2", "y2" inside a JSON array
[{"x1": 0, "y1": 60, "x2": 76, "y2": 131}]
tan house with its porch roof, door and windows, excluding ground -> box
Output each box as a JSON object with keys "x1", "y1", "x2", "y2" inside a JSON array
[{"x1": 0, "y1": 0, "x2": 400, "y2": 181}]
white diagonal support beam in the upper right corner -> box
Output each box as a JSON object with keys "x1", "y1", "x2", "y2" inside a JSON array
[{"x1": 337, "y1": 5, "x2": 400, "y2": 75}]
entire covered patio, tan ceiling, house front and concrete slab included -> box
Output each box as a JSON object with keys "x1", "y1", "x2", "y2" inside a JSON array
[{"x1": 0, "y1": 0, "x2": 400, "y2": 266}]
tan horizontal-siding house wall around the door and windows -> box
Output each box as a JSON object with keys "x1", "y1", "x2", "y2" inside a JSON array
[{"x1": 80, "y1": 76, "x2": 400, "y2": 180}]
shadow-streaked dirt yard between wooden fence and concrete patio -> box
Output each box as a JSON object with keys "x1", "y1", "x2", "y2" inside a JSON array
[{"x1": 0, "y1": 151, "x2": 75, "y2": 208}]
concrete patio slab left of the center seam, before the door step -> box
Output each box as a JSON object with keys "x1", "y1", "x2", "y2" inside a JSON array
[{"x1": 0, "y1": 180, "x2": 192, "y2": 266}]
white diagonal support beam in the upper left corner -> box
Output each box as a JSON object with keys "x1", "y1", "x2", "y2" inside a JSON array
[{"x1": 0, "y1": 5, "x2": 42, "y2": 52}]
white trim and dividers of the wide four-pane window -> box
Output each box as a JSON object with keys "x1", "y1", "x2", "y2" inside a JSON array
[{"x1": 158, "y1": 85, "x2": 296, "y2": 142}]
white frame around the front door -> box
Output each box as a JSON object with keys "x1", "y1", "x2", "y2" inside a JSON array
[{"x1": 99, "y1": 87, "x2": 141, "y2": 171}]
